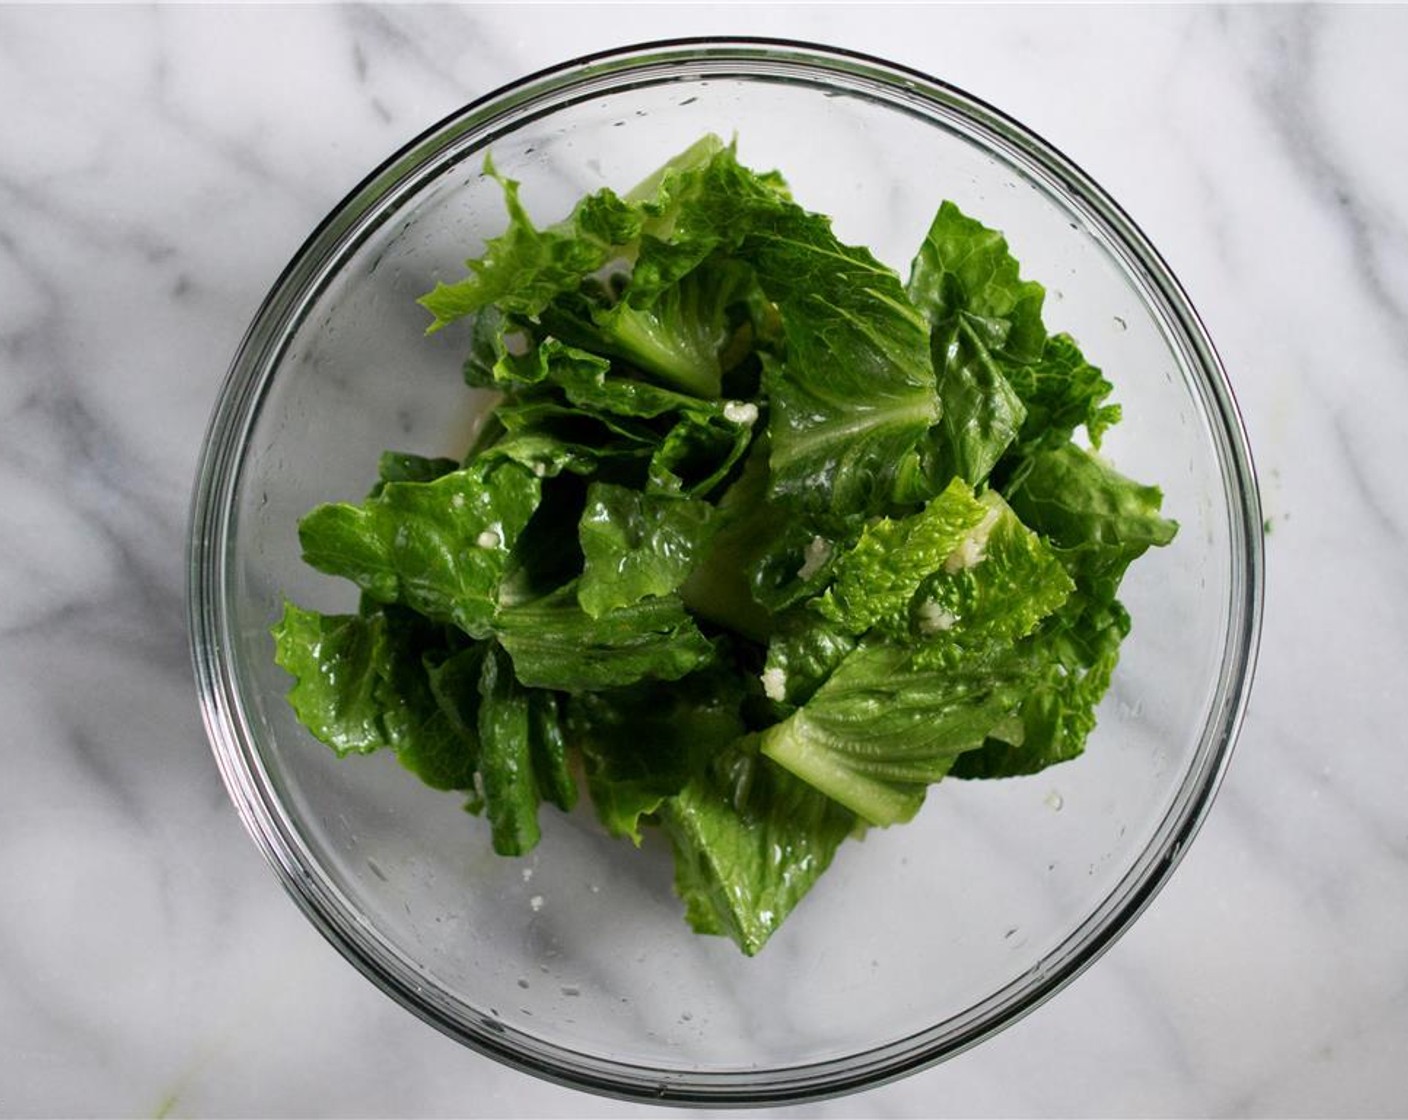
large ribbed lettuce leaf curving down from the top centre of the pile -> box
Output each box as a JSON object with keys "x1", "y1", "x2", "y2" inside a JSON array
[{"x1": 605, "y1": 141, "x2": 938, "y2": 518}]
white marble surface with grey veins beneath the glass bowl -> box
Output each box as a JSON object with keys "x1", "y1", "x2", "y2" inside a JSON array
[{"x1": 0, "y1": 4, "x2": 1408, "y2": 1116}]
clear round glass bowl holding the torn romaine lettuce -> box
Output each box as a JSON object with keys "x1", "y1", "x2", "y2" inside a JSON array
[{"x1": 190, "y1": 39, "x2": 1262, "y2": 1105}]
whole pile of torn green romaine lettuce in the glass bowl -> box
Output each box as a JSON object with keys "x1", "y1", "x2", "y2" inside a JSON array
[{"x1": 273, "y1": 137, "x2": 1177, "y2": 954}]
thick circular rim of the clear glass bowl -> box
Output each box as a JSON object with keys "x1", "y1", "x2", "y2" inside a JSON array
[{"x1": 186, "y1": 35, "x2": 1264, "y2": 1107}]
